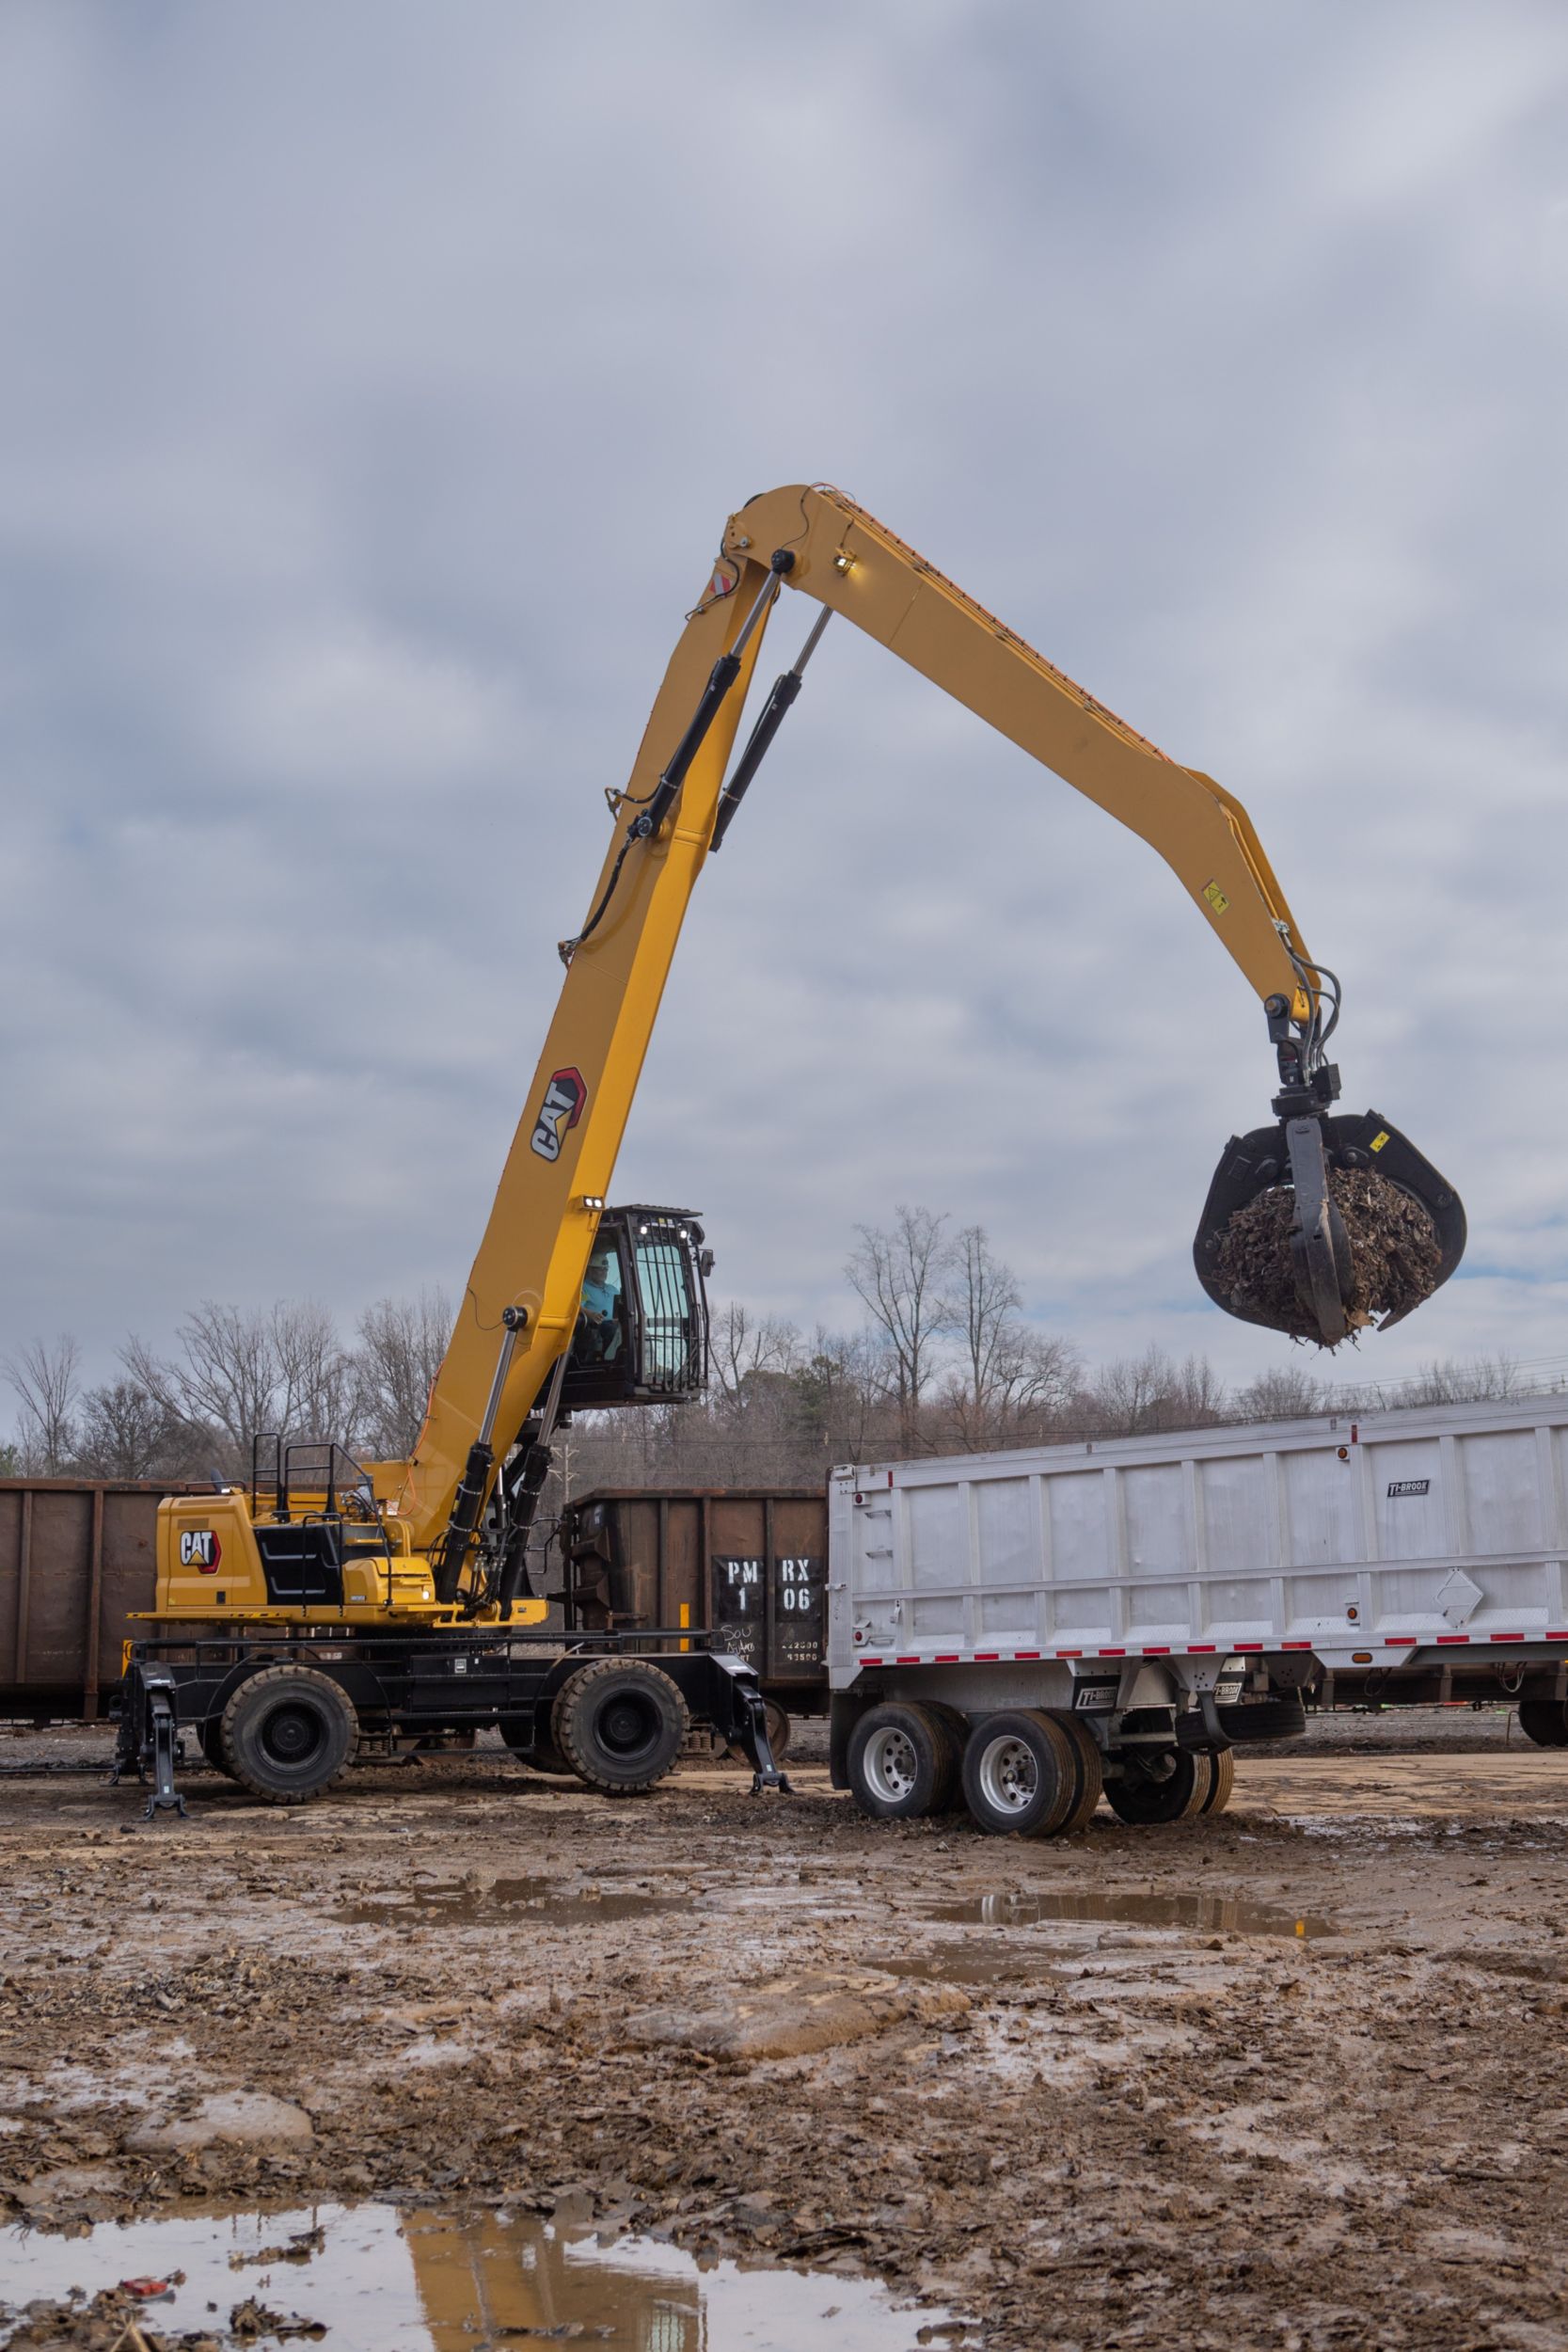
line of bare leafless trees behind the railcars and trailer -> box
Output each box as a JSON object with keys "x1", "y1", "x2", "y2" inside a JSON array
[{"x1": 0, "y1": 1207, "x2": 1561, "y2": 1499}]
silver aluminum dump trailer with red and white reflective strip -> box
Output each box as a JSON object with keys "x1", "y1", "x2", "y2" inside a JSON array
[{"x1": 828, "y1": 1395, "x2": 1568, "y2": 1835}]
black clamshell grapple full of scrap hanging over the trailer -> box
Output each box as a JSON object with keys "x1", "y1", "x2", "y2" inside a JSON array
[{"x1": 1192, "y1": 1110, "x2": 1465, "y2": 1348}]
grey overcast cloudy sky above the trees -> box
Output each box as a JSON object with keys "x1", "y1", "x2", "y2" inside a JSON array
[{"x1": 0, "y1": 0, "x2": 1568, "y2": 1421}]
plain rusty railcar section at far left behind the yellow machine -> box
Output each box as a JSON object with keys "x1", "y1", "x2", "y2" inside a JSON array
[{"x1": 0, "y1": 1477, "x2": 201, "y2": 1722}]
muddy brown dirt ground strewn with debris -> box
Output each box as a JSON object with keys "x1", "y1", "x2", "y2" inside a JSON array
[{"x1": 0, "y1": 1717, "x2": 1568, "y2": 2352}]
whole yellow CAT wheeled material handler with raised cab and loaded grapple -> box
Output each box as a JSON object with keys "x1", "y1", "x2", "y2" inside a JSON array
[{"x1": 122, "y1": 487, "x2": 1465, "y2": 1802}]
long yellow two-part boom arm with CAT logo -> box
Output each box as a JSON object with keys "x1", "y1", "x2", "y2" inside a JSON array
[{"x1": 373, "y1": 487, "x2": 1312, "y2": 1550}]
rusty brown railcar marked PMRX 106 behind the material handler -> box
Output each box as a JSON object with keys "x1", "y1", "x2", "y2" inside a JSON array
[{"x1": 562, "y1": 1486, "x2": 828, "y2": 1715}]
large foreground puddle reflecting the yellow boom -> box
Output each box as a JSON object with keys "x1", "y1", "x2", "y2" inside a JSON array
[{"x1": 0, "y1": 2204, "x2": 964, "y2": 2352}]
